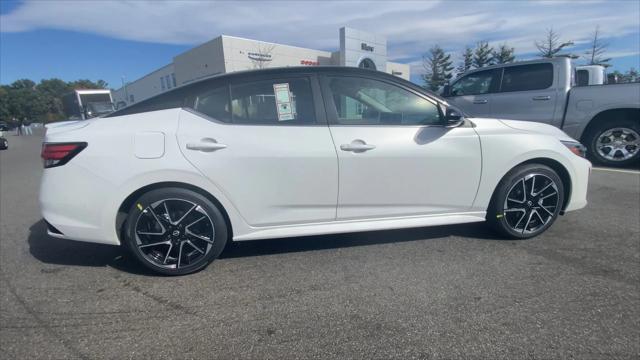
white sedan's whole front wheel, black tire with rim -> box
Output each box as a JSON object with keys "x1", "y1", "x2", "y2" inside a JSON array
[{"x1": 487, "y1": 164, "x2": 564, "y2": 239}]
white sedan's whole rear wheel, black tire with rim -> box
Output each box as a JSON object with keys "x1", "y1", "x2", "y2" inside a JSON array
[{"x1": 125, "y1": 187, "x2": 229, "y2": 275}]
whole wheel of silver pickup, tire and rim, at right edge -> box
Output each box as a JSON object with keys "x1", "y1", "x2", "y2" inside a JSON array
[{"x1": 586, "y1": 119, "x2": 640, "y2": 166}]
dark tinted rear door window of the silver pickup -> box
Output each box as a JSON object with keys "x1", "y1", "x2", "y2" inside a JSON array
[{"x1": 500, "y1": 63, "x2": 553, "y2": 92}]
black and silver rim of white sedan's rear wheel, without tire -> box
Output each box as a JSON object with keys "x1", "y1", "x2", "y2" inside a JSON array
[{"x1": 135, "y1": 198, "x2": 215, "y2": 269}]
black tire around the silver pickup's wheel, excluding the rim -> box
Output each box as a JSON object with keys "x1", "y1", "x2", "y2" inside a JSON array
[{"x1": 584, "y1": 119, "x2": 640, "y2": 167}]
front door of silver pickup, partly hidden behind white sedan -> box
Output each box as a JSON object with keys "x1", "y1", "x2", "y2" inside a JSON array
[{"x1": 447, "y1": 69, "x2": 500, "y2": 117}]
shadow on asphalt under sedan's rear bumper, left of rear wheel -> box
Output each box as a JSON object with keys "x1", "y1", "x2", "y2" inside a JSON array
[{"x1": 28, "y1": 220, "x2": 154, "y2": 275}]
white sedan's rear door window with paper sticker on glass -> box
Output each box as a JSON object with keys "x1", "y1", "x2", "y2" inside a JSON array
[{"x1": 231, "y1": 78, "x2": 316, "y2": 125}]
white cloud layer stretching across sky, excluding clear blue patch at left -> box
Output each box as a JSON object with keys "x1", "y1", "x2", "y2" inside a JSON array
[{"x1": 0, "y1": 1, "x2": 640, "y2": 64}]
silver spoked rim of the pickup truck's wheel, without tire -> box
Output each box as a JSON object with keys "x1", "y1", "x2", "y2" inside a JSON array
[{"x1": 595, "y1": 127, "x2": 640, "y2": 161}]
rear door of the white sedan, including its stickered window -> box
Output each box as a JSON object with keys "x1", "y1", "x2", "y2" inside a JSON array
[{"x1": 178, "y1": 76, "x2": 338, "y2": 226}]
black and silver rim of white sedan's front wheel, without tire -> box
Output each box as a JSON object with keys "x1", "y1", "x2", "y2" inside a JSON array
[{"x1": 503, "y1": 174, "x2": 560, "y2": 234}]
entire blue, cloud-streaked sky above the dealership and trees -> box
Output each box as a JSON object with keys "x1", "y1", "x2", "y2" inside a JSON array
[{"x1": 0, "y1": 0, "x2": 640, "y2": 88}]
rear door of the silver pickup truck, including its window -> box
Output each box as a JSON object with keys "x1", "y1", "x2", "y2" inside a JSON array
[{"x1": 484, "y1": 63, "x2": 562, "y2": 126}]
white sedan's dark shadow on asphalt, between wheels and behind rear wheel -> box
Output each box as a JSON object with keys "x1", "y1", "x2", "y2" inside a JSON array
[{"x1": 28, "y1": 220, "x2": 498, "y2": 276}]
